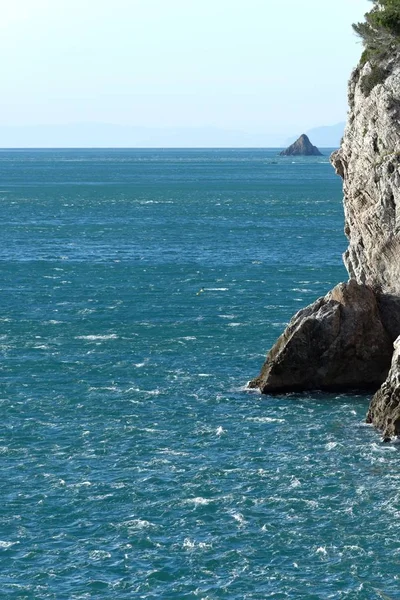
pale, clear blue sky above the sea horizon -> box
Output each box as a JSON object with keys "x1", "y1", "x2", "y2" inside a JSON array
[{"x1": 0, "y1": 0, "x2": 371, "y2": 146}]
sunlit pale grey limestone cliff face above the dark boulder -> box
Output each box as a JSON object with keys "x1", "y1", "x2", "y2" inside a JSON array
[{"x1": 331, "y1": 56, "x2": 400, "y2": 296}]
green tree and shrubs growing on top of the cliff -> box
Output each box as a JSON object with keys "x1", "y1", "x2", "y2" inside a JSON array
[{"x1": 353, "y1": 0, "x2": 400, "y2": 62}]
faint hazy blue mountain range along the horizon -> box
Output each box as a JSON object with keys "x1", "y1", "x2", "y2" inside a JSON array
[{"x1": 0, "y1": 123, "x2": 344, "y2": 148}]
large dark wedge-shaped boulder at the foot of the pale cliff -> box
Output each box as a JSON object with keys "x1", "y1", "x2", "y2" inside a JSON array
[{"x1": 249, "y1": 280, "x2": 393, "y2": 394}]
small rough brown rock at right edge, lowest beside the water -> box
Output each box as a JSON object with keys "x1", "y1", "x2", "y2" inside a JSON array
[{"x1": 367, "y1": 338, "x2": 400, "y2": 439}]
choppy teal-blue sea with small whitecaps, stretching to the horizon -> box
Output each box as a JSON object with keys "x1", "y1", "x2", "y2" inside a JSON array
[{"x1": 0, "y1": 150, "x2": 400, "y2": 600}]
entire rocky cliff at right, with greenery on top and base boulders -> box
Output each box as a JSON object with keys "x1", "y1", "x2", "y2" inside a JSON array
[{"x1": 249, "y1": 0, "x2": 400, "y2": 439}]
